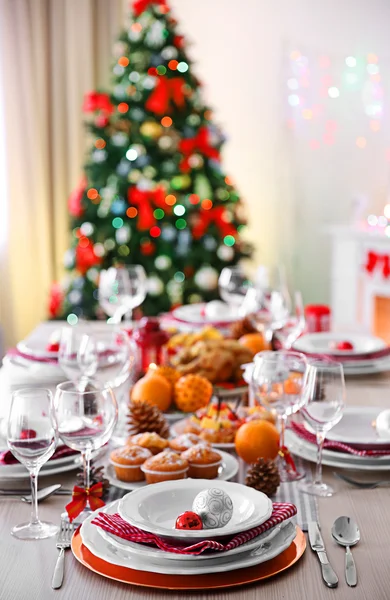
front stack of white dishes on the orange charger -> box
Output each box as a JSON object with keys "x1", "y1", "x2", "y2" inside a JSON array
[{"x1": 81, "y1": 479, "x2": 296, "y2": 575}]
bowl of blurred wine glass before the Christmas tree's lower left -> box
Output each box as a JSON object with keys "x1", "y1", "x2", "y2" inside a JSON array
[{"x1": 99, "y1": 265, "x2": 147, "y2": 323}]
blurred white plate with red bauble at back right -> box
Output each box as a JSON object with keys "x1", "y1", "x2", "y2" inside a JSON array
[{"x1": 293, "y1": 332, "x2": 387, "y2": 356}]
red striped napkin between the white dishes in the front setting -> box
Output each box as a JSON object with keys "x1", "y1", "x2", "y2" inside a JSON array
[{"x1": 92, "y1": 502, "x2": 297, "y2": 555}]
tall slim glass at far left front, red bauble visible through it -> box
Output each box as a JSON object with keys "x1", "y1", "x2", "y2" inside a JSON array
[{"x1": 7, "y1": 388, "x2": 58, "y2": 540}]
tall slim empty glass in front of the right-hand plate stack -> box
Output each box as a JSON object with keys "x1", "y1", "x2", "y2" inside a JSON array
[{"x1": 299, "y1": 359, "x2": 345, "y2": 496}]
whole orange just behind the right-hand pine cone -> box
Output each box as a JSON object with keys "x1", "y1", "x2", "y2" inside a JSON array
[{"x1": 235, "y1": 420, "x2": 279, "y2": 464}]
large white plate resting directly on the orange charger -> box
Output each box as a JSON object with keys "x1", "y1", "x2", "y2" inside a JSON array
[{"x1": 80, "y1": 502, "x2": 296, "y2": 575}]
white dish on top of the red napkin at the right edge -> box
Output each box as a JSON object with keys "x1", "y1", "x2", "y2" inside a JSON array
[{"x1": 326, "y1": 406, "x2": 390, "y2": 449}]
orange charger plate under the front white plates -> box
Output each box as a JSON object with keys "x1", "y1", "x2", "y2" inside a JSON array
[{"x1": 72, "y1": 527, "x2": 306, "y2": 590}]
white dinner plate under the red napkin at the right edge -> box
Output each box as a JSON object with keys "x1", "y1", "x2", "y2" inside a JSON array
[{"x1": 286, "y1": 430, "x2": 390, "y2": 471}]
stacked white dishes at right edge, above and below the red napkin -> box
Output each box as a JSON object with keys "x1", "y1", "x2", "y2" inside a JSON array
[{"x1": 286, "y1": 406, "x2": 390, "y2": 471}]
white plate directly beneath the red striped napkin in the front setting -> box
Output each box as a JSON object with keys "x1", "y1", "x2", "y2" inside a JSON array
[{"x1": 97, "y1": 500, "x2": 291, "y2": 563}]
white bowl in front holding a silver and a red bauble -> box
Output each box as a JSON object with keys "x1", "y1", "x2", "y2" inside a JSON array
[{"x1": 118, "y1": 479, "x2": 272, "y2": 544}]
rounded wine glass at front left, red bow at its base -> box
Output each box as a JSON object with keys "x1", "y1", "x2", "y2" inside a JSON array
[{"x1": 54, "y1": 380, "x2": 118, "y2": 521}]
